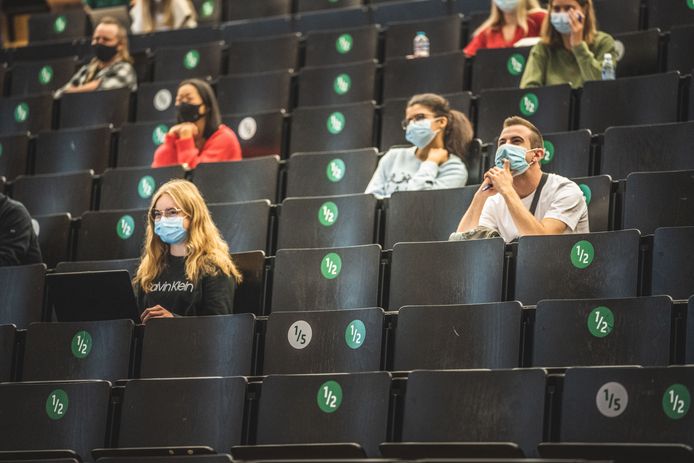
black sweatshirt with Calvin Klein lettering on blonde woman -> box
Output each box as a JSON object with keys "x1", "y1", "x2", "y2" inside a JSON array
[{"x1": 137, "y1": 254, "x2": 236, "y2": 316}]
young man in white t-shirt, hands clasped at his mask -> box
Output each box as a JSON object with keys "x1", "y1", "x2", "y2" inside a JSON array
[{"x1": 451, "y1": 116, "x2": 590, "y2": 243}]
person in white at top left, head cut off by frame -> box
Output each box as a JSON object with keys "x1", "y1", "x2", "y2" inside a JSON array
[{"x1": 130, "y1": 0, "x2": 198, "y2": 34}]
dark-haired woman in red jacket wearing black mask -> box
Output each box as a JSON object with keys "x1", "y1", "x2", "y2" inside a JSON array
[{"x1": 152, "y1": 79, "x2": 241, "y2": 169}]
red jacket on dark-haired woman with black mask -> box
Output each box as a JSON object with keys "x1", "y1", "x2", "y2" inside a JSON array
[{"x1": 152, "y1": 124, "x2": 241, "y2": 169}]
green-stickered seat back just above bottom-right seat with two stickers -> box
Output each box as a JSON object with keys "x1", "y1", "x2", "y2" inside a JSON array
[{"x1": 532, "y1": 296, "x2": 672, "y2": 367}]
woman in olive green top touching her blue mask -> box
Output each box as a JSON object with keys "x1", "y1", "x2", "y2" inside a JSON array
[{"x1": 520, "y1": 0, "x2": 617, "y2": 88}]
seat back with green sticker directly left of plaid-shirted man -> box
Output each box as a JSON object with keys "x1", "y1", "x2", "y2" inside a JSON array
[{"x1": 10, "y1": 56, "x2": 77, "y2": 95}]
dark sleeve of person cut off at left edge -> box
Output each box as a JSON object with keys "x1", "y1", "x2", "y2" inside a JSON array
[{"x1": 0, "y1": 193, "x2": 42, "y2": 266}]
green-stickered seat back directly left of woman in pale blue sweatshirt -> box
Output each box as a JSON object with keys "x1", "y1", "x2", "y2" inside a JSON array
[{"x1": 286, "y1": 148, "x2": 378, "y2": 197}]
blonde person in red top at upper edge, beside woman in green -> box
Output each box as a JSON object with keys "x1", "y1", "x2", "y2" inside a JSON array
[{"x1": 463, "y1": 0, "x2": 547, "y2": 57}]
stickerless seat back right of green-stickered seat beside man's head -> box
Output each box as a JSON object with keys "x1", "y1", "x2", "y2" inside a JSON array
[{"x1": 600, "y1": 122, "x2": 694, "y2": 179}]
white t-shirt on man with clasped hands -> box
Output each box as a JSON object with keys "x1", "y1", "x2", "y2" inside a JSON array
[{"x1": 479, "y1": 174, "x2": 590, "y2": 243}]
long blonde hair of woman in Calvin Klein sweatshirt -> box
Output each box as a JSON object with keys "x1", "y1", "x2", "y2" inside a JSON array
[{"x1": 133, "y1": 179, "x2": 241, "y2": 292}]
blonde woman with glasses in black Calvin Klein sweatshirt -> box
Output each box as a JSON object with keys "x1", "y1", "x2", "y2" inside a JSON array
[{"x1": 133, "y1": 179, "x2": 241, "y2": 323}]
